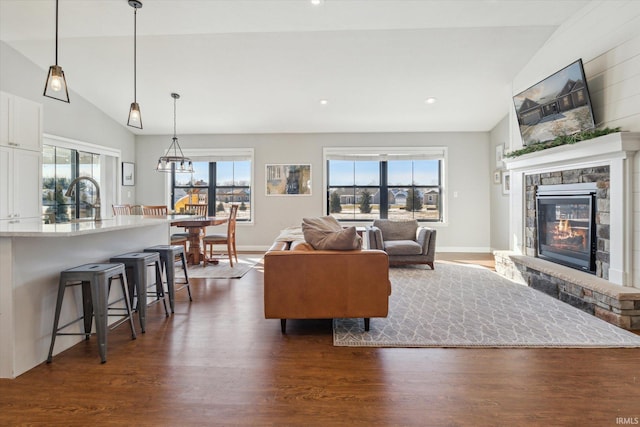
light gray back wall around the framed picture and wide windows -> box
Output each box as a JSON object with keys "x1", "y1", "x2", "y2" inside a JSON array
[{"x1": 136, "y1": 132, "x2": 491, "y2": 252}]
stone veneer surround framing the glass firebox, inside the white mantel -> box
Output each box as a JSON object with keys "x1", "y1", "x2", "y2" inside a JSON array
[{"x1": 525, "y1": 166, "x2": 610, "y2": 279}]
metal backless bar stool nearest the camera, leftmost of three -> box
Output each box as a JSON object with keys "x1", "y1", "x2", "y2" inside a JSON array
[{"x1": 47, "y1": 263, "x2": 136, "y2": 363}]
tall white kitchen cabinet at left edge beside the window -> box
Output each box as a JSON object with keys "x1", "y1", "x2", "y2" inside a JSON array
[{"x1": 0, "y1": 146, "x2": 42, "y2": 221}]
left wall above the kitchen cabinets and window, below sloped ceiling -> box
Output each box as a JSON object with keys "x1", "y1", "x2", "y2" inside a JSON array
[{"x1": 0, "y1": 42, "x2": 136, "y2": 203}]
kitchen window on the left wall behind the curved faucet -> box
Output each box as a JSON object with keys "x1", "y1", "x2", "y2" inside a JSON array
[{"x1": 42, "y1": 145, "x2": 100, "y2": 222}]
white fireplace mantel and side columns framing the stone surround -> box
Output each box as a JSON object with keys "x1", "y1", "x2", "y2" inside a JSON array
[{"x1": 504, "y1": 132, "x2": 640, "y2": 288}]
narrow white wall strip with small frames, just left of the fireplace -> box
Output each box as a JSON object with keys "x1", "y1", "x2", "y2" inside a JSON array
[{"x1": 489, "y1": 116, "x2": 510, "y2": 250}]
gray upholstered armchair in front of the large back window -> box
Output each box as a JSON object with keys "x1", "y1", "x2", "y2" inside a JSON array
[{"x1": 366, "y1": 219, "x2": 436, "y2": 269}]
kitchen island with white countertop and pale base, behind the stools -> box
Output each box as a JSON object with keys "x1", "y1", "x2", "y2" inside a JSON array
[{"x1": 0, "y1": 215, "x2": 188, "y2": 378}]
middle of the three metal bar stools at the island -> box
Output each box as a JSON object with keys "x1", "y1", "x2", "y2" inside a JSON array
[{"x1": 109, "y1": 252, "x2": 169, "y2": 333}]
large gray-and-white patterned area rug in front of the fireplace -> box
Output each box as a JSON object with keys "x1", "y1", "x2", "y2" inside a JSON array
[{"x1": 333, "y1": 262, "x2": 640, "y2": 347}]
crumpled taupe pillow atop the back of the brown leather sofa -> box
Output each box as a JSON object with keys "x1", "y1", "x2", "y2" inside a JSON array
[{"x1": 302, "y1": 216, "x2": 362, "y2": 251}]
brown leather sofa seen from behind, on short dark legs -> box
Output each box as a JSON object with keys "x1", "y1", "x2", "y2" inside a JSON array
[{"x1": 264, "y1": 241, "x2": 391, "y2": 333}]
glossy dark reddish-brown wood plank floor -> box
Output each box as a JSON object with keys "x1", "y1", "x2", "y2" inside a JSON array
[{"x1": 0, "y1": 257, "x2": 640, "y2": 426}]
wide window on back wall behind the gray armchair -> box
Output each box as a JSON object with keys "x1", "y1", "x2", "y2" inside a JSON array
[{"x1": 325, "y1": 148, "x2": 446, "y2": 222}]
